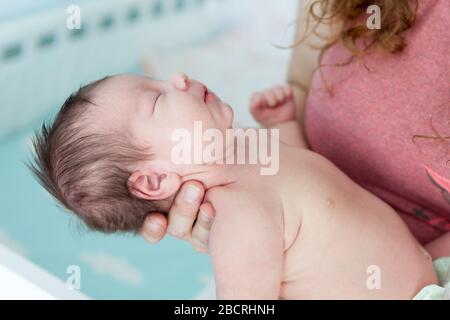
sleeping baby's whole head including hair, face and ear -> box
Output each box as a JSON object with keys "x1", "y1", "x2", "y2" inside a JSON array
[{"x1": 31, "y1": 74, "x2": 233, "y2": 232}]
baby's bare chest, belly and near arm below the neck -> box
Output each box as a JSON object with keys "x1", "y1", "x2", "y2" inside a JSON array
[{"x1": 206, "y1": 146, "x2": 437, "y2": 299}]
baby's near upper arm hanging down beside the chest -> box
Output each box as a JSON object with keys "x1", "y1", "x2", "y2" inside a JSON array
[{"x1": 209, "y1": 192, "x2": 283, "y2": 299}]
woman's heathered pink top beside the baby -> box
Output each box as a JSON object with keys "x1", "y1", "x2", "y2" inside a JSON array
[{"x1": 305, "y1": 0, "x2": 450, "y2": 243}]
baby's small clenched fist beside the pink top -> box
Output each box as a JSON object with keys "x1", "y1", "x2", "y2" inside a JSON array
[{"x1": 250, "y1": 85, "x2": 295, "y2": 127}]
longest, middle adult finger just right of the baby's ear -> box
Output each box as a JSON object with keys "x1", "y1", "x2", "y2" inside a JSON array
[{"x1": 167, "y1": 181, "x2": 205, "y2": 238}]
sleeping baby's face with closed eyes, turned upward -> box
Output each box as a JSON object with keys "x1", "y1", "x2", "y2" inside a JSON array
[{"x1": 93, "y1": 74, "x2": 233, "y2": 166}]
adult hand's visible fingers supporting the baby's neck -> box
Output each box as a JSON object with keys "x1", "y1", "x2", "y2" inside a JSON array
[{"x1": 140, "y1": 181, "x2": 215, "y2": 253}]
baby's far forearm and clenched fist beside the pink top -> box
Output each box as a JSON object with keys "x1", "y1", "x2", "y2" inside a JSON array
[{"x1": 250, "y1": 85, "x2": 308, "y2": 149}]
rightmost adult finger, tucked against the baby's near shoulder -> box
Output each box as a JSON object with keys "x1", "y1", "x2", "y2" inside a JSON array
[{"x1": 192, "y1": 202, "x2": 215, "y2": 253}]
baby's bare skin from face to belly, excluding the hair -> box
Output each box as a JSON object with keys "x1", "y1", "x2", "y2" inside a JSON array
[{"x1": 92, "y1": 74, "x2": 437, "y2": 299}]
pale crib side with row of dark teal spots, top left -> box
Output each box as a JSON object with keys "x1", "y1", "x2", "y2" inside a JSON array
[{"x1": 0, "y1": 0, "x2": 236, "y2": 137}]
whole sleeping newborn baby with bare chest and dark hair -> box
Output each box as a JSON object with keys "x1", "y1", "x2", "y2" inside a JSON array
[{"x1": 29, "y1": 74, "x2": 437, "y2": 299}]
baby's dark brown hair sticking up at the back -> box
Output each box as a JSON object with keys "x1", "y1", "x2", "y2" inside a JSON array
[{"x1": 28, "y1": 77, "x2": 169, "y2": 233}]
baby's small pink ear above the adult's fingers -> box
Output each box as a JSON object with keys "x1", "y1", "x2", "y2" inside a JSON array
[{"x1": 127, "y1": 170, "x2": 181, "y2": 200}]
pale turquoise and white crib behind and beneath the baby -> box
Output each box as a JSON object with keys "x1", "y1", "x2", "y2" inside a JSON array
[{"x1": 0, "y1": 0, "x2": 296, "y2": 299}]
